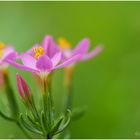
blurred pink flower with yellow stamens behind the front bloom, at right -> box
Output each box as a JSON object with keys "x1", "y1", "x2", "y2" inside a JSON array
[{"x1": 59, "y1": 38, "x2": 103, "y2": 64}]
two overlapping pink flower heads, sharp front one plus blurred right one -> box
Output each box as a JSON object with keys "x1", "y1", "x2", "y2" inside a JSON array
[{"x1": 3, "y1": 35, "x2": 102, "y2": 75}]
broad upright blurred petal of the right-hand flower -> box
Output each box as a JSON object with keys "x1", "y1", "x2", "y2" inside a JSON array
[{"x1": 72, "y1": 38, "x2": 90, "y2": 55}]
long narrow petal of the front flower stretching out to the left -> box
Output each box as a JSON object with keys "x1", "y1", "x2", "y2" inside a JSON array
[{"x1": 6, "y1": 59, "x2": 39, "y2": 73}]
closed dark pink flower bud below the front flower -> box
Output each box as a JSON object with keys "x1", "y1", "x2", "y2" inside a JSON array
[{"x1": 16, "y1": 73, "x2": 31, "y2": 99}]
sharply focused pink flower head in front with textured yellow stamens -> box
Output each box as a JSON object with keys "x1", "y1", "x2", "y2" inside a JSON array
[{"x1": 6, "y1": 36, "x2": 81, "y2": 74}]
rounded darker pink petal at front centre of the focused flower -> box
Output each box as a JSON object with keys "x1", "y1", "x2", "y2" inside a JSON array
[{"x1": 36, "y1": 55, "x2": 53, "y2": 71}]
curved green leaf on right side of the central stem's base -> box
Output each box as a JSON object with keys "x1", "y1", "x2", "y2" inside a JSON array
[{"x1": 54, "y1": 110, "x2": 71, "y2": 135}]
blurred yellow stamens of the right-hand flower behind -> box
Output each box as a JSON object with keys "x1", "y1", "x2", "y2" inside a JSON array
[{"x1": 58, "y1": 38, "x2": 71, "y2": 49}]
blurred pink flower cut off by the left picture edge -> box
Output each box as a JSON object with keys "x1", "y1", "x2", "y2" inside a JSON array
[{"x1": 0, "y1": 42, "x2": 17, "y2": 69}]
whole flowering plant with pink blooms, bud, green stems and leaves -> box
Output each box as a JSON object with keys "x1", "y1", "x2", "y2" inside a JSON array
[{"x1": 0, "y1": 35, "x2": 103, "y2": 138}]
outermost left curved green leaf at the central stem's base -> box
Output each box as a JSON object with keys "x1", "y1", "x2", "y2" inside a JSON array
[{"x1": 19, "y1": 114, "x2": 43, "y2": 135}]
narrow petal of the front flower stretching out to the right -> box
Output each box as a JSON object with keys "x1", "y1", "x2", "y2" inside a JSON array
[{"x1": 55, "y1": 54, "x2": 81, "y2": 69}]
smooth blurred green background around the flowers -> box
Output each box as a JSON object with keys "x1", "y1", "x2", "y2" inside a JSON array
[{"x1": 0, "y1": 2, "x2": 140, "y2": 138}]
